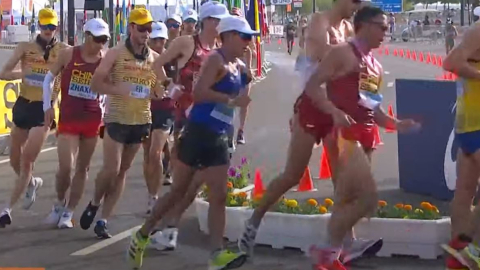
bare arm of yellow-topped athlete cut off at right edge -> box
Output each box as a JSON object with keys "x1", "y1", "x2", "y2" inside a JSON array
[{"x1": 443, "y1": 24, "x2": 480, "y2": 80}]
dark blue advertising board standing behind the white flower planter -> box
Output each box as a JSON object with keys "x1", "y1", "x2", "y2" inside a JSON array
[{"x1": 395, "y1": 79, "x2": 458, "y2": 200}]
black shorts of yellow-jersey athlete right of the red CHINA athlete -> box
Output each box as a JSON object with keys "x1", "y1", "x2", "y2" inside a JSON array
[{"x1": 105, "y1": 123, "x2": 151, "y2": 144}]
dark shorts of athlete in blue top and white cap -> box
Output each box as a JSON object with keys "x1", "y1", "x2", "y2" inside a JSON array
[{"x1": 178, "y1": 121, "x2": 230, "y2": 169}]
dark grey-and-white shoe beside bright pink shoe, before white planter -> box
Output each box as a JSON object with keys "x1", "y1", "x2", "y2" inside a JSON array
[{"x1": 340, "y1": 239, "x2": 383, "y2": 264}]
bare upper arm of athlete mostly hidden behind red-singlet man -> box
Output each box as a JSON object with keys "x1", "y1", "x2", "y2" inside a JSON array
[{"x1": 305, "y1": 13, "x2": 330, "y2": 62}]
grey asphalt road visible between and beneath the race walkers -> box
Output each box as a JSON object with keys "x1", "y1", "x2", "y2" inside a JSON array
[{"x1": 0, "y1": 42, "x2": 447, "y2": 270}]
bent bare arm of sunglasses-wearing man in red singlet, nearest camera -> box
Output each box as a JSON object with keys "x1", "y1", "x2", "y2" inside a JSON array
[{"x1": 305, "y1": 44, "x2": 358, "y2": 114}]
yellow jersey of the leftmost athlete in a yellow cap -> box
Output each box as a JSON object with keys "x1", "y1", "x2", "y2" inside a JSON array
[{"x1": 20, "y1": 41, "x2": 67, "y2": 101}]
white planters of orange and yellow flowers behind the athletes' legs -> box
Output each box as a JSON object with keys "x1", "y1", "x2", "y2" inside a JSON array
[{"x1": 196, "y1": 194, "x2": 450, "y2": 259}]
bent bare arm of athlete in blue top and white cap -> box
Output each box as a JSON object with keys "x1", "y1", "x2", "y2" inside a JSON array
[{"x1": 193, "y1": 53, "x2": 230, "y2": 103}]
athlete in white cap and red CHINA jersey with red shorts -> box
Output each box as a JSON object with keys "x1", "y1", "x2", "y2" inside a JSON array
[{"x1": 43, "y1": 19, "x2": 110, "y2": 228}]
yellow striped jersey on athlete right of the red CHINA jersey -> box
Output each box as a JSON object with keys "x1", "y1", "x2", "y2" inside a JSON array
[{"x1": 104, "y1": 45, "x2": 157, "y2": 125}]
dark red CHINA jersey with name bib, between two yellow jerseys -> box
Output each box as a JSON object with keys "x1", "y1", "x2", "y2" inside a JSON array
[{"x1": 60, "y1": 46, "x2": 102, "y2": 122}]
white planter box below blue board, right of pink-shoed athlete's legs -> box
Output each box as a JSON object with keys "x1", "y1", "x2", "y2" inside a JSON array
[{"x1": 355, "y1": 217, "x2": 450, "y2": 259}]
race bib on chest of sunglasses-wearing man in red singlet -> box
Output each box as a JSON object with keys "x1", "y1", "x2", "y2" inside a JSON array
[{"x1": 358, "y1": 72, "x2": 383, "y2": 110}]
